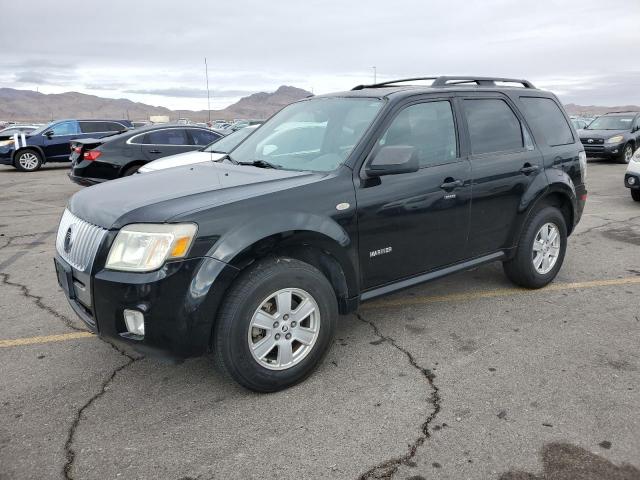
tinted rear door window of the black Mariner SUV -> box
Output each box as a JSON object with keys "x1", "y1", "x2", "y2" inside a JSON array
[{"x1": 464, "y1": 98, "x2": 523, "y2": 154}]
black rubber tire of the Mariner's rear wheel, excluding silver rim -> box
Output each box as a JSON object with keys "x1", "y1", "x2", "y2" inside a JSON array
[{"x1": 503, "y1": 206, "x2": 567, "y2": 288}]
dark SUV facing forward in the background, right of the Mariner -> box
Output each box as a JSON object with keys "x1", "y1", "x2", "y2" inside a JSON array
[{"x1": 580, "y1": 112, "x2": 640, "y2": 163}]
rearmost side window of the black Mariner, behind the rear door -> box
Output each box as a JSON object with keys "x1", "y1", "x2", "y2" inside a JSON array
[{"x1": 520, "y1": 97, "x2": 574, "y2": 147}]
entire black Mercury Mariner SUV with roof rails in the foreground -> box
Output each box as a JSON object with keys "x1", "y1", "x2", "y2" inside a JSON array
[{"x1": 55, "y1": 77, "x2": 587, "y2": 391}]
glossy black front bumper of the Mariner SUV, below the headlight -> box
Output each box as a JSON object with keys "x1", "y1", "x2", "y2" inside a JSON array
[{"x1": 55, "y1": 255, "x2": 237, "y2": 358}]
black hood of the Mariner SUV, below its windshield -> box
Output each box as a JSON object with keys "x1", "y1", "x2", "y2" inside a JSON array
[{"x1": 67, "y1": 162, "x2": 325, "y2": 229}]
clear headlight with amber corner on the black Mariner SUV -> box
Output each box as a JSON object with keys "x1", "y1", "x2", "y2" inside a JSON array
[{"x1": 106, "y1": 223, "x2": 198, "y2": 272}]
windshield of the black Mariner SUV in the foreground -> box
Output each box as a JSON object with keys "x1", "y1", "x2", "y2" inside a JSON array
[{"x1": 233, "y1": 98, "x2": 383, "y2": 172}]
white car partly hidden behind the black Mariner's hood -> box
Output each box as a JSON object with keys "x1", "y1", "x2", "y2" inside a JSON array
[{"x1": 138, "y1": 125, "x2": 259, "y2": 173}]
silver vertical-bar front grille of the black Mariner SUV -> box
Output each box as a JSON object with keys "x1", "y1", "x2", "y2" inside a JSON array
[{"x1": 56, "y1": 210, "x2": 107, "y2": 272}]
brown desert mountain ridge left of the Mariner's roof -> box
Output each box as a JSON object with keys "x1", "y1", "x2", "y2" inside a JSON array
[{"x1": 0, "y1": 86, "x2": 311, "y2": 122}]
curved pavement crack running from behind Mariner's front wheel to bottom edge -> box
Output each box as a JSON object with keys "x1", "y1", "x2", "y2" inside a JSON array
[{"x1": 356, "y1": 313, "x2": 442, "y2": 480}]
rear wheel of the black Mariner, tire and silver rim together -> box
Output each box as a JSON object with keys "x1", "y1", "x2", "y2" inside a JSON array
[{"x1": 503, "y1": 207, "x2": 567, "y2": 288}]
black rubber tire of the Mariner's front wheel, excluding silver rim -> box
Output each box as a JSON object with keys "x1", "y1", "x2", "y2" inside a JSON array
[{"x1": 214, "y1": 257, "x2": 338, "y2": 392}]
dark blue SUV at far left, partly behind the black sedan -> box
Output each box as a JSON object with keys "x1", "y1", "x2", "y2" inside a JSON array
[{"x1": 0, "y1": 120, "x2": 131, "y2": 172}]
